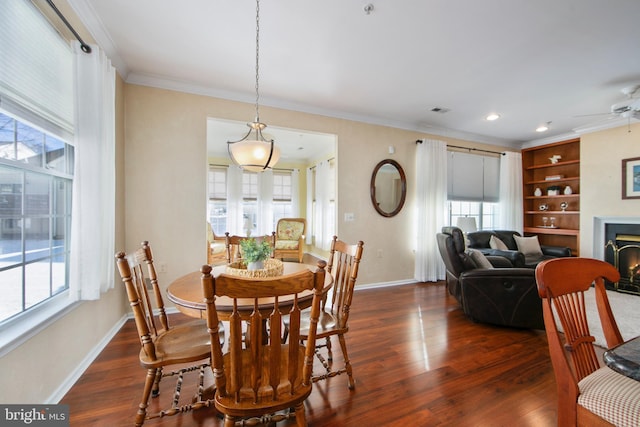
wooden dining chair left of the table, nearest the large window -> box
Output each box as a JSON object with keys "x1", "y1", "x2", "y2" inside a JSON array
[{"x1": 116, "y1": 241, "x2": 215, "y2": 426}]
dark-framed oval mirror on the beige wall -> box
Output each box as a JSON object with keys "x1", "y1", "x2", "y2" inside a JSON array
[{"x1": 370, "y1": 159, "x2": 407, "y2": 217}]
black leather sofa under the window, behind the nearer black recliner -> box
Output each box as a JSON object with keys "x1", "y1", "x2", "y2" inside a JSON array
[{"x1": 467, "y1": 230, "x2": 571, "y2": 268}]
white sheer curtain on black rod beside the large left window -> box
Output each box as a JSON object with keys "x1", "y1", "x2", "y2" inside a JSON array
[{"x1": 69, "y1": 42, "x2": 115, "y2": 300}]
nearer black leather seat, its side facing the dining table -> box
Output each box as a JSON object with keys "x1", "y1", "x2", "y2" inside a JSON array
[{"x1": 436, "y1": 227, "x2": 544, "y2": 329}]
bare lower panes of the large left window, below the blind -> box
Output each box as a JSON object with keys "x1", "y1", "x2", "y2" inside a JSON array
[{"x1": 0, "y1": 112, "x2": 74, "y2": 323}]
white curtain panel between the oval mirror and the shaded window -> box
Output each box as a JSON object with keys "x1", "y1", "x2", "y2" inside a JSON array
[{"x1": 414, "y1": 139, "x2": 447, "y2": 282}]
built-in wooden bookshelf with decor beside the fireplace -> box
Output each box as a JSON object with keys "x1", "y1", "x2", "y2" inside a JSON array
[{"x1": 522, "y1": 138, "x2": 580, "y2": 256}]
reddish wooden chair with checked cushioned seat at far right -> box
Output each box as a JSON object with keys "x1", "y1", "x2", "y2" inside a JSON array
[{"x1": 536, "y1": 258, "x2": 640, "y2": 427}]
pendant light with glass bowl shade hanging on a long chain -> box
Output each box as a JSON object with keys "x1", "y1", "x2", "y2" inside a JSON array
[{"x1": 227, "y1": 0, "x2": 280, "y2": 172}]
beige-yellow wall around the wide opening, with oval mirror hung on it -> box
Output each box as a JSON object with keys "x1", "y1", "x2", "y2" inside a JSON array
[{"x1": 125, "y1": 85, "x2": 510, "y2": 285}]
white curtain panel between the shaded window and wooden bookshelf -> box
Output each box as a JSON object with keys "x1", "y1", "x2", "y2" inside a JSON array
[{"x1": 498, "y1": 151, "x2": 523, "y2": 233}]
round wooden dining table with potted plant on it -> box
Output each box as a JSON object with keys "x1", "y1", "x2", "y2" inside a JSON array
[{"x1": 167, "y1": 262, "x2": 333, "y2": 320}]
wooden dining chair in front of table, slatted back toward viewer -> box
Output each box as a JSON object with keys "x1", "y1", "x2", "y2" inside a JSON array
[{"x1": 201, "y1": 261, "x2": 326, "y2": 427}]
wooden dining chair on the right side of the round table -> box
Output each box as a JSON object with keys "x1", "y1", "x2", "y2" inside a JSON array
[{"x1": 284, "y1": 236, "x2": 364, "y2": 390}]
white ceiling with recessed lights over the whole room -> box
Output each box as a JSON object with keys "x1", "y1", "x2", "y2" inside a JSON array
[{"x1": 69, "y1": 0, "x2": 640, "y2": 156}]
